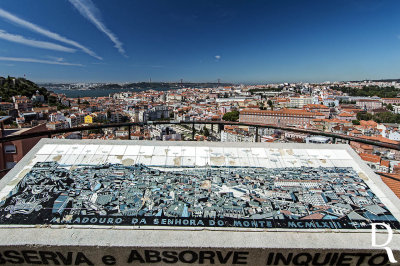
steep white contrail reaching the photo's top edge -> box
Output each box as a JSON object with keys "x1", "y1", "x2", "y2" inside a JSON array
[{"x1": 69, "y1": 0, "x2": 126, "y2": 57}]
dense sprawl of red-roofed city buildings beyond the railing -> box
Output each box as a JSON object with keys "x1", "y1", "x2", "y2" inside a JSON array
[{"x1": 0, "y1": 79, "x2": 400, "y2": 201}]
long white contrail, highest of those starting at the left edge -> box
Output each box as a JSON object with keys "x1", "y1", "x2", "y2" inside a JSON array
[{"x1": 0, "y1": 8, "x2": 102, "y2": 60}]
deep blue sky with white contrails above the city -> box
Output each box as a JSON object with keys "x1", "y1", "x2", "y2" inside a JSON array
[{"x1": 0, "y1": 0, "x2": 400, "y2": 83}]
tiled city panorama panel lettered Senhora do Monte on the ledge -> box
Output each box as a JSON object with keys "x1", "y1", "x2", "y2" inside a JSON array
[{"x1": 0, "y1": 144, "x2": 399, "y2": 229}]
